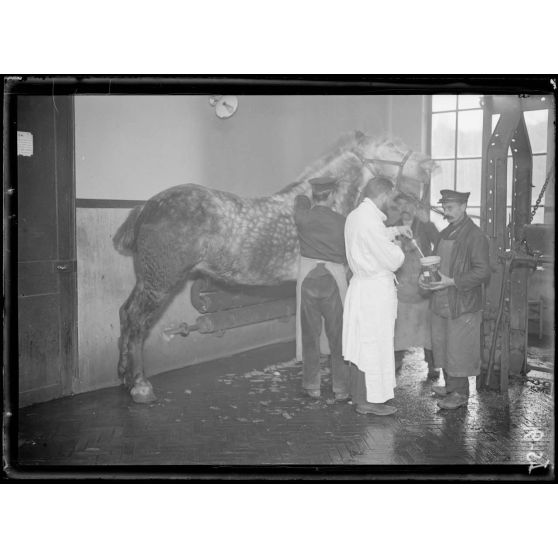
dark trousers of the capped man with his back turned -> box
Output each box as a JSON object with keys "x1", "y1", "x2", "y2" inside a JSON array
[{"x1": 300, "y1": 265, "x2": 348, "y2": 393}]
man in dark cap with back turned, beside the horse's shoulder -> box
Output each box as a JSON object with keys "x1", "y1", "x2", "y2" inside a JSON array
[{"x1": 294, "y1": 177, "x2": 349, "y2": 401}]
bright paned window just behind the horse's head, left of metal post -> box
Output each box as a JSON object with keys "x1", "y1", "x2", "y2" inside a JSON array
[{"x1": 430, "y1": 95, "x2": 483, "y2": 229}]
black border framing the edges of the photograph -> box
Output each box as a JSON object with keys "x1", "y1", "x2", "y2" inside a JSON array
[{"x1": 2, "y1": 74, "x2": 557, "y2": 483}]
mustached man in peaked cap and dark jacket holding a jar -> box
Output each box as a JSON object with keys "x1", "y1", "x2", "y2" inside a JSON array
[{"x1": 420, "y1": 190, "x2": 490, "y2": 409}]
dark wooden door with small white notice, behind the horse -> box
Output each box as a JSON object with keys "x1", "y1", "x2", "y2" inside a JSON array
[{"x1": 16, "y1": 95, "x2": 77, "y2": 407}]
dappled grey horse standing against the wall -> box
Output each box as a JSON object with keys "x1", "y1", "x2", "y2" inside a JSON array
[{"x1": 113, "y1": 132, "x2": 435, "y2": 403}]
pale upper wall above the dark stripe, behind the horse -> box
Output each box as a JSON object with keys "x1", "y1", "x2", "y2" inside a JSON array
[{"x1": 76, "y1": 95, "x2": 394, "y2": 199}]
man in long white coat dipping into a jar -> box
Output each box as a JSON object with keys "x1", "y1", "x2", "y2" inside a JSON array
[{"x1": 343, "y1": 177, "x2": 412, "y2": 415}]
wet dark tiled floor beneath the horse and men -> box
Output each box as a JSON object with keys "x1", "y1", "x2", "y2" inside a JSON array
[{"x1": 17, "y1": 343, "x2": 554, "y2": 472}]
